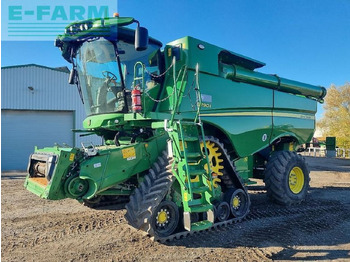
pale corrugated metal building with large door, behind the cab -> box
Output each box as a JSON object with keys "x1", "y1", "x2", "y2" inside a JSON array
[{"x1": 1, "y1": 64, "x2": 101, "y2": 171}]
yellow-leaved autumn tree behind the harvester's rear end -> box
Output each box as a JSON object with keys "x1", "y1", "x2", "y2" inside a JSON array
[{"x1": 317, "y1": 83, "x2": 350, "y2": 148}]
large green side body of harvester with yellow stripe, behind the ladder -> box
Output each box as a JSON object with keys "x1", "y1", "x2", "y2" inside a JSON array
[{"x1": 154, "y1": 37, "x2": 316, "y2": 157}]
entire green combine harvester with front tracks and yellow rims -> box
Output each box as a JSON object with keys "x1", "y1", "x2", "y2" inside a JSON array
[{"x1": 25, "y1": 14, "x2": 326, "y2": 240}]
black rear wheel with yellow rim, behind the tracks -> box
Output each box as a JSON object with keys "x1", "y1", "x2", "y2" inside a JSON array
[{"x1": 264, "y1": 151, "x2": 310, "y2": 206}]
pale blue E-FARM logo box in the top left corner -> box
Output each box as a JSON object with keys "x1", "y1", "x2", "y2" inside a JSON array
[{"x1": 1, "y1": 0, "x2": 117, "y2": 41}]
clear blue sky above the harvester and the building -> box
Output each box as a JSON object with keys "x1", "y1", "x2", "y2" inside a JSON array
[{"x1": 1, "y1": 0, "x2": 350, "y2": 118}]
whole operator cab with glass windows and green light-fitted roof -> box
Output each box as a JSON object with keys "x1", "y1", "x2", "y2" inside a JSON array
[{"x1": 55, "y1": 17, "x2": 164, "y2": 116}]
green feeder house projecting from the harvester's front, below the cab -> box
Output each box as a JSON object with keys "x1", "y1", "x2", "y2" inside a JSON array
[{"x1": 25, "y1": 134, "x2": 168, "y2": 200}]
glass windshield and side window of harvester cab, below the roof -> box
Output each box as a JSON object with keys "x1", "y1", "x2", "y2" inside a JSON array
[{"x1": 76, "y1": 29, "x2": 161, "y2": 116}]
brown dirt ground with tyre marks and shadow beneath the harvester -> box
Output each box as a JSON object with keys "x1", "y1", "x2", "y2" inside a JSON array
[{"x1": 1, "y1": 157, "x2": 350, "y2": 261}]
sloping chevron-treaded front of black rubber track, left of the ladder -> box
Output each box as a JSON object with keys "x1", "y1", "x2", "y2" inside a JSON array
[{"x1": 125, "y1": 151, "x2": 175, "y2": 236}]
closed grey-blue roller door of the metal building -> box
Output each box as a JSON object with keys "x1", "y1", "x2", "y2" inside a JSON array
[{"x1": 1, "y1": 110, "x2": 74, "y2": 170}]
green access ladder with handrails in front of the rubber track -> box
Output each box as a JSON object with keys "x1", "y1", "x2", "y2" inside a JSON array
[{"x1": 165, "y1": 64, "x2": 214, "y2": 231}]
